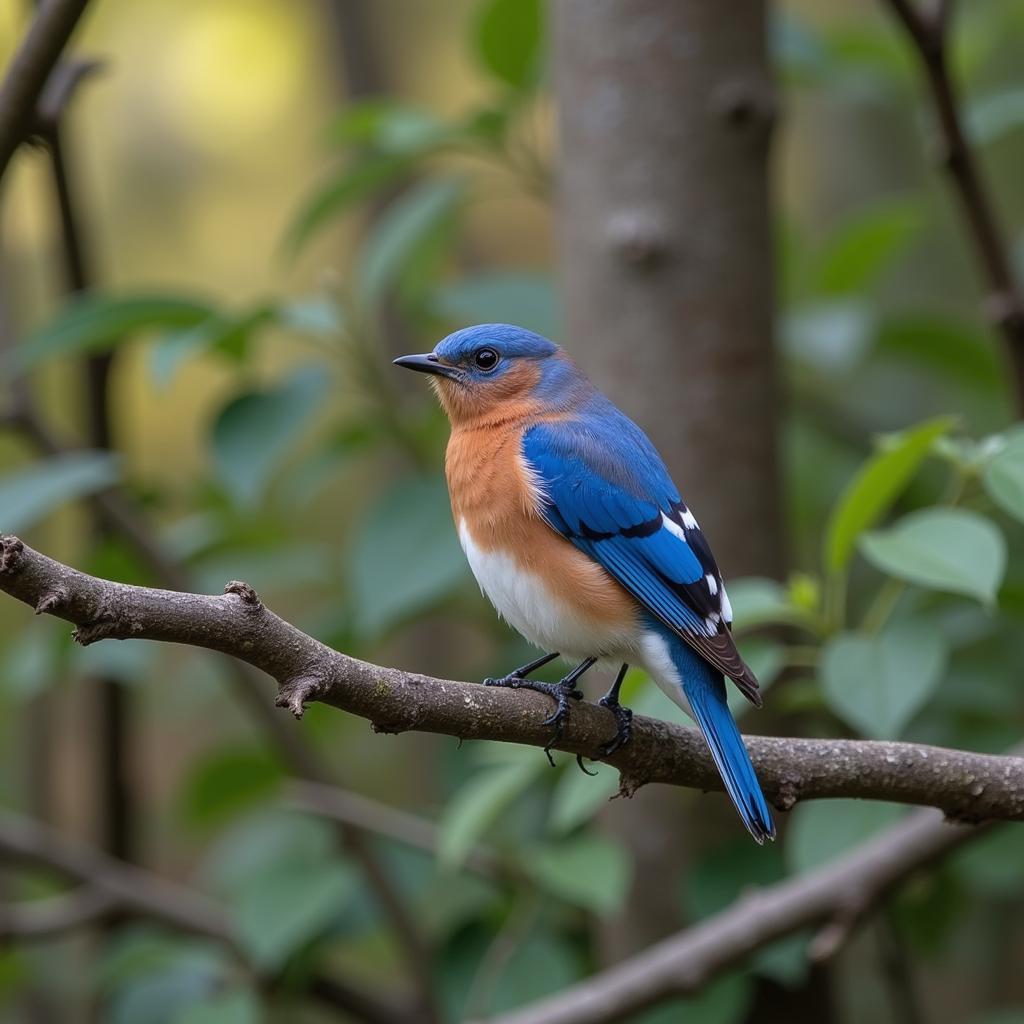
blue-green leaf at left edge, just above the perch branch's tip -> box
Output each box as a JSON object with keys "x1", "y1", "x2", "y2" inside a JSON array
[{"x1": 0, "y1": 452, "x2": 120, "y2": 534}]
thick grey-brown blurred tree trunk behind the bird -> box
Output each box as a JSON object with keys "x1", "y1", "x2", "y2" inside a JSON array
[{"x1": 553, "y1": 0, "x2": 783, "y2": 958}]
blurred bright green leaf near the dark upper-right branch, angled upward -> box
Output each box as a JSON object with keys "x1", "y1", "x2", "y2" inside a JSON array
[{"x1": 813, "y1": 199, "x2": 925, "y2": 295}]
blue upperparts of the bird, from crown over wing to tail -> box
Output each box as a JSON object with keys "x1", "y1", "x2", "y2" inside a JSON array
[{"x1": 434, "y1": 324, "x2": 774, "y2": 842}]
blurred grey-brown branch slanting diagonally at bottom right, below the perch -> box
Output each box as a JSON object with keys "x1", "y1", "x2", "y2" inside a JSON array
[{"x1": 490, "y1": 810, "x2": 986, "y2": 1024}]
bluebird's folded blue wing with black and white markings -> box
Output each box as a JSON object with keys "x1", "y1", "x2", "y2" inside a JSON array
[{"x1": 522, "y1": 409, "x2": 761, "y2": 705}]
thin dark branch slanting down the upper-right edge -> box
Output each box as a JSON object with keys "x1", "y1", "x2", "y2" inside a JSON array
[{"x1": 888, "y1": 0, "x2": 1024, "y2": 409}]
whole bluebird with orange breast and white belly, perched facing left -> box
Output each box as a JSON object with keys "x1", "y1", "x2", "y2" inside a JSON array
[{"x1": 394, "y1": 324, "x2": 775, "y2": 843}]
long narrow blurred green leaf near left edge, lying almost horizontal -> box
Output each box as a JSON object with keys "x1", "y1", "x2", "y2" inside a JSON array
[{"x1": 13, "y1": 294, "x2": 216, "y2": 370}]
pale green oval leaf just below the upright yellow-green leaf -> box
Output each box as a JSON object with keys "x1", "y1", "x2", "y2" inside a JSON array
[{"x1": 860, "y1": 508, "x2": 1007, "y2": 604}]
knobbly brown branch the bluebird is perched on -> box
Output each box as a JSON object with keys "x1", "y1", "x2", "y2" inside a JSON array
[{"x1": 0, "y1": 537, "x2": 1024, "y2": 821}]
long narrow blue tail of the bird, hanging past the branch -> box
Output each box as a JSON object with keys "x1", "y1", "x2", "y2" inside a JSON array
[{"x1": 672, "y1": 638, "x2": 775, "y2": 843}]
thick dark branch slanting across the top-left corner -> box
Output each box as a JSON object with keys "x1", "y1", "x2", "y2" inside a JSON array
[{"x1": 0, "y1": 0, "x2": 88, "y2": 178}]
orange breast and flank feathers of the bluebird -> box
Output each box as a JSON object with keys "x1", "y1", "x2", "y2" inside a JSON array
[{"x1": 445, "y1": 411, "x2": 639, "y2": 633}]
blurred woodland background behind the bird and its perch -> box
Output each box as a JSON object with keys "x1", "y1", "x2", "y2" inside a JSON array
[{"x1": 0, "y1": 0, "x2": 1024, "y2": 1024}]
